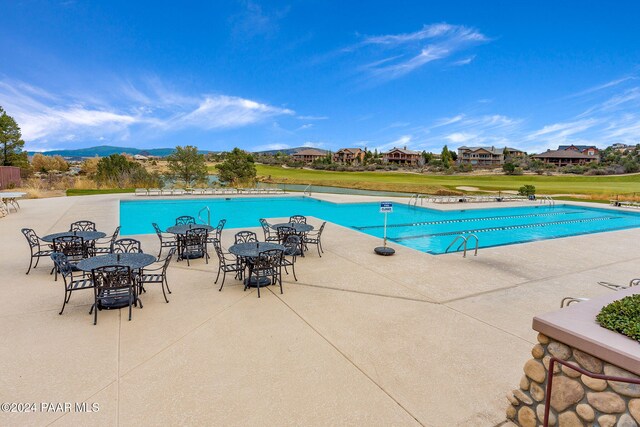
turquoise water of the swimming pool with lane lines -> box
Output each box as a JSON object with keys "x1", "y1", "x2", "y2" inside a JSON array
[{"x1": 120, "y1": 197, "x2": 640, "y2": 254}]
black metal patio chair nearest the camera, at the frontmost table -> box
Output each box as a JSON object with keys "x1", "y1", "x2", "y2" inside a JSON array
[{"x1": 89, "y1": 265, "x2": 142, "y2": 325}]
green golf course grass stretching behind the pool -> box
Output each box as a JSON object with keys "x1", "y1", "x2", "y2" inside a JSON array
[{"x1": 256, "y1": 165, "x2": 640, "y2": 199}]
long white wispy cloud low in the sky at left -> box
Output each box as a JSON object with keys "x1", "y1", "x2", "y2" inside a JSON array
[{"x1": 0, "y1": 80, "x2": 295, "y2": 149}]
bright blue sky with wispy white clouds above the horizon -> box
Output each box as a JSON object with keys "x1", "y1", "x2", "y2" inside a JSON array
[{"x1": 0, "y1": 0, "x2": 640, "y2": 152}]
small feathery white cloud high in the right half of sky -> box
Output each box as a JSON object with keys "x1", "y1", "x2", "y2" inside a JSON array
[{"x1": 350, "y1": 23, "x2": 490, "y2": 80}]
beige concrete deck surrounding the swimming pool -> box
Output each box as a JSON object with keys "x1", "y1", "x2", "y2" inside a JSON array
[{"x1": 0, "y1": 194, "x2": 640, "y2": 426}]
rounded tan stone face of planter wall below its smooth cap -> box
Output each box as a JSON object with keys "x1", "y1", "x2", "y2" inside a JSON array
[{"x1": 507, "y1": 334, "x2": 640, "y2": 427}]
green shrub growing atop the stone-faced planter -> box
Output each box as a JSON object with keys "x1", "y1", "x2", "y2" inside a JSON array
[{"x1": 596, "y1": 294, "x2": 640, "y2": 341}]
